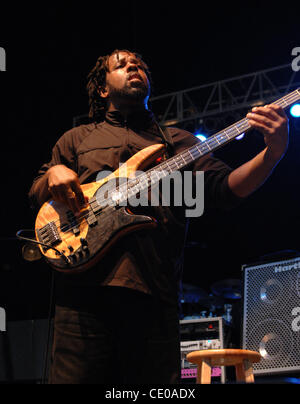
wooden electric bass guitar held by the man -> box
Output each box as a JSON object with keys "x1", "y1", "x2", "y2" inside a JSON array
[{"x1": 35, "y1": 88, "x2": 300, "y2": 273}]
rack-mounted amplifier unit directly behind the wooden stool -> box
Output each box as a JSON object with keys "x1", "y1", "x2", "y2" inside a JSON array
[{"x1": 180, "y1": 317, "x2": 225, "y2": 383}]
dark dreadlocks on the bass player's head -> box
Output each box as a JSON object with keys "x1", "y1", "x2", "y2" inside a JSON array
[{"x1": 86, "y1": 49, "x2": 152, "y2": 122}]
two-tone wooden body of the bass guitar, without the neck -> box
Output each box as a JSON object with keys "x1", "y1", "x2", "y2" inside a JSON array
[{"x1": 35, "y1": 144, "x2": 165, "y2": 273}]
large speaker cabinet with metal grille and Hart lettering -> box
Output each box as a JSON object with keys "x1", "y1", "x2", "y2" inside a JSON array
[{"x1": 242, "y1": 257, "x2": 300, "y2": 375}]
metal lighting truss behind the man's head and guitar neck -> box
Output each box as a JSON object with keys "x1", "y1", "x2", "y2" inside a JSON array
[{"x1": 73, "y1": 64, "x2": 300, "y2": 131}]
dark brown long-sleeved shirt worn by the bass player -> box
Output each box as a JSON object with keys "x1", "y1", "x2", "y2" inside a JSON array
[{"x1": 29, "y1": 111, "x2": 240, "y2": 304}]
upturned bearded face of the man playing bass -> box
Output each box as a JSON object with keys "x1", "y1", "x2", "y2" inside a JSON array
[{"x1": 101, "y1": 52, "x2": 150, "y2": 103}]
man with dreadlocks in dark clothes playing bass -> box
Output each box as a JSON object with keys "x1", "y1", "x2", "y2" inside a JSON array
[{"x1": 30, "y1": 50, "x2": 289, "y2": 384}]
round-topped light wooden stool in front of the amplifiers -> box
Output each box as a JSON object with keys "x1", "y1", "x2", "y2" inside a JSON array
[{"x1": 186, "y1": 349, "x2": 261, "y2": 384}]
